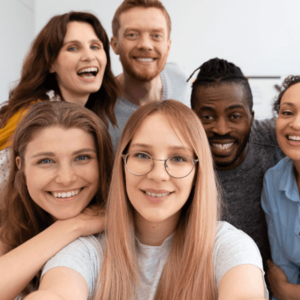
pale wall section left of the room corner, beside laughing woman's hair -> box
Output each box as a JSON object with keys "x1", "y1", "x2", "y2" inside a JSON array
[{"x1": 0, "y1": 0, "x2": 34, "y2": 104}]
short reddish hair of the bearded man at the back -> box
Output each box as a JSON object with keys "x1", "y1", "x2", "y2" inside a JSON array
[{"x1": 112, "y1": 0, "x2": 171, "y2": 37}]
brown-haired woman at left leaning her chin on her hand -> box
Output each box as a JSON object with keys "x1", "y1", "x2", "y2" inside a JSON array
[{"x1": 0, "y1": 101, "x2": 113, "y2": 300}]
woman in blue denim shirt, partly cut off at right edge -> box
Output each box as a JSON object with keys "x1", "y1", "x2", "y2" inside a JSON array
[{"x1": 261, "y1": 76, "x2": 300, "y2": 299}]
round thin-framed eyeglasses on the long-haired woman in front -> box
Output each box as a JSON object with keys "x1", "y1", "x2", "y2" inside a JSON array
[{"x1": 122, "y1": 151, "x2": 199, "y2": 178}]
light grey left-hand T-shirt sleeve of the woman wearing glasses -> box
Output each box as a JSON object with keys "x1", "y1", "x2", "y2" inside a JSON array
[{"x1": 41, "y1": 236, "x2": 102, "y2": 299}]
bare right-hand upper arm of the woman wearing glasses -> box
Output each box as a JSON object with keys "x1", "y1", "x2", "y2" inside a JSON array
[{"x1": 218, "y1": 265, "x2": 266, "y2": 300}]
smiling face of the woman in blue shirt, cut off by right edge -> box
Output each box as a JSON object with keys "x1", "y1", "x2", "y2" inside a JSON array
[{"x1": 276, "y1": 83, "x2": 300, "y2": 169}]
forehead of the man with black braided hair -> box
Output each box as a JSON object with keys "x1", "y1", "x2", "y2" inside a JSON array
[{"x1": 194, "y1": 83, "x2": 249, "y2": 111}]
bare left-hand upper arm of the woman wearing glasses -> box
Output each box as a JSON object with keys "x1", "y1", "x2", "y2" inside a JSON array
[{"x1": 25, "y1": 267, "x2": 88, "y2": 300}]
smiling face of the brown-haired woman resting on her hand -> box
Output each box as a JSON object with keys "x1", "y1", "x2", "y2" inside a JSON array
[{"x1": 17, "y1": 127, "x2": 99, "y2": 220}]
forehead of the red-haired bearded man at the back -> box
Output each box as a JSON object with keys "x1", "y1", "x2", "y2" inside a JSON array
[{"x1": 120, "y1": 7, "x2": 168, "y2": 32}]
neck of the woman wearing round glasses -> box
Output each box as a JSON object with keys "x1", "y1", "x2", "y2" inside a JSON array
[{"x1": 135, "y1": 211, "x2": 181, "y2": 246}]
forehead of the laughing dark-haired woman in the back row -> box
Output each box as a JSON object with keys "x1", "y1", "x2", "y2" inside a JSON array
[{"x1": 64, "y1": 21, "x2": 98, "y2": 42}]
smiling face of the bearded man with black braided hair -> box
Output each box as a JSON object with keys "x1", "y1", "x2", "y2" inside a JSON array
[{"x1": 194, "y1": 83, "x2": 254, "y2": 170}]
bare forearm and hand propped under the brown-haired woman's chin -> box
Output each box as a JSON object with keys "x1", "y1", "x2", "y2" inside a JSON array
[{"x1": 0, "y1": 209, "x2": 104, "y2": 300}]
